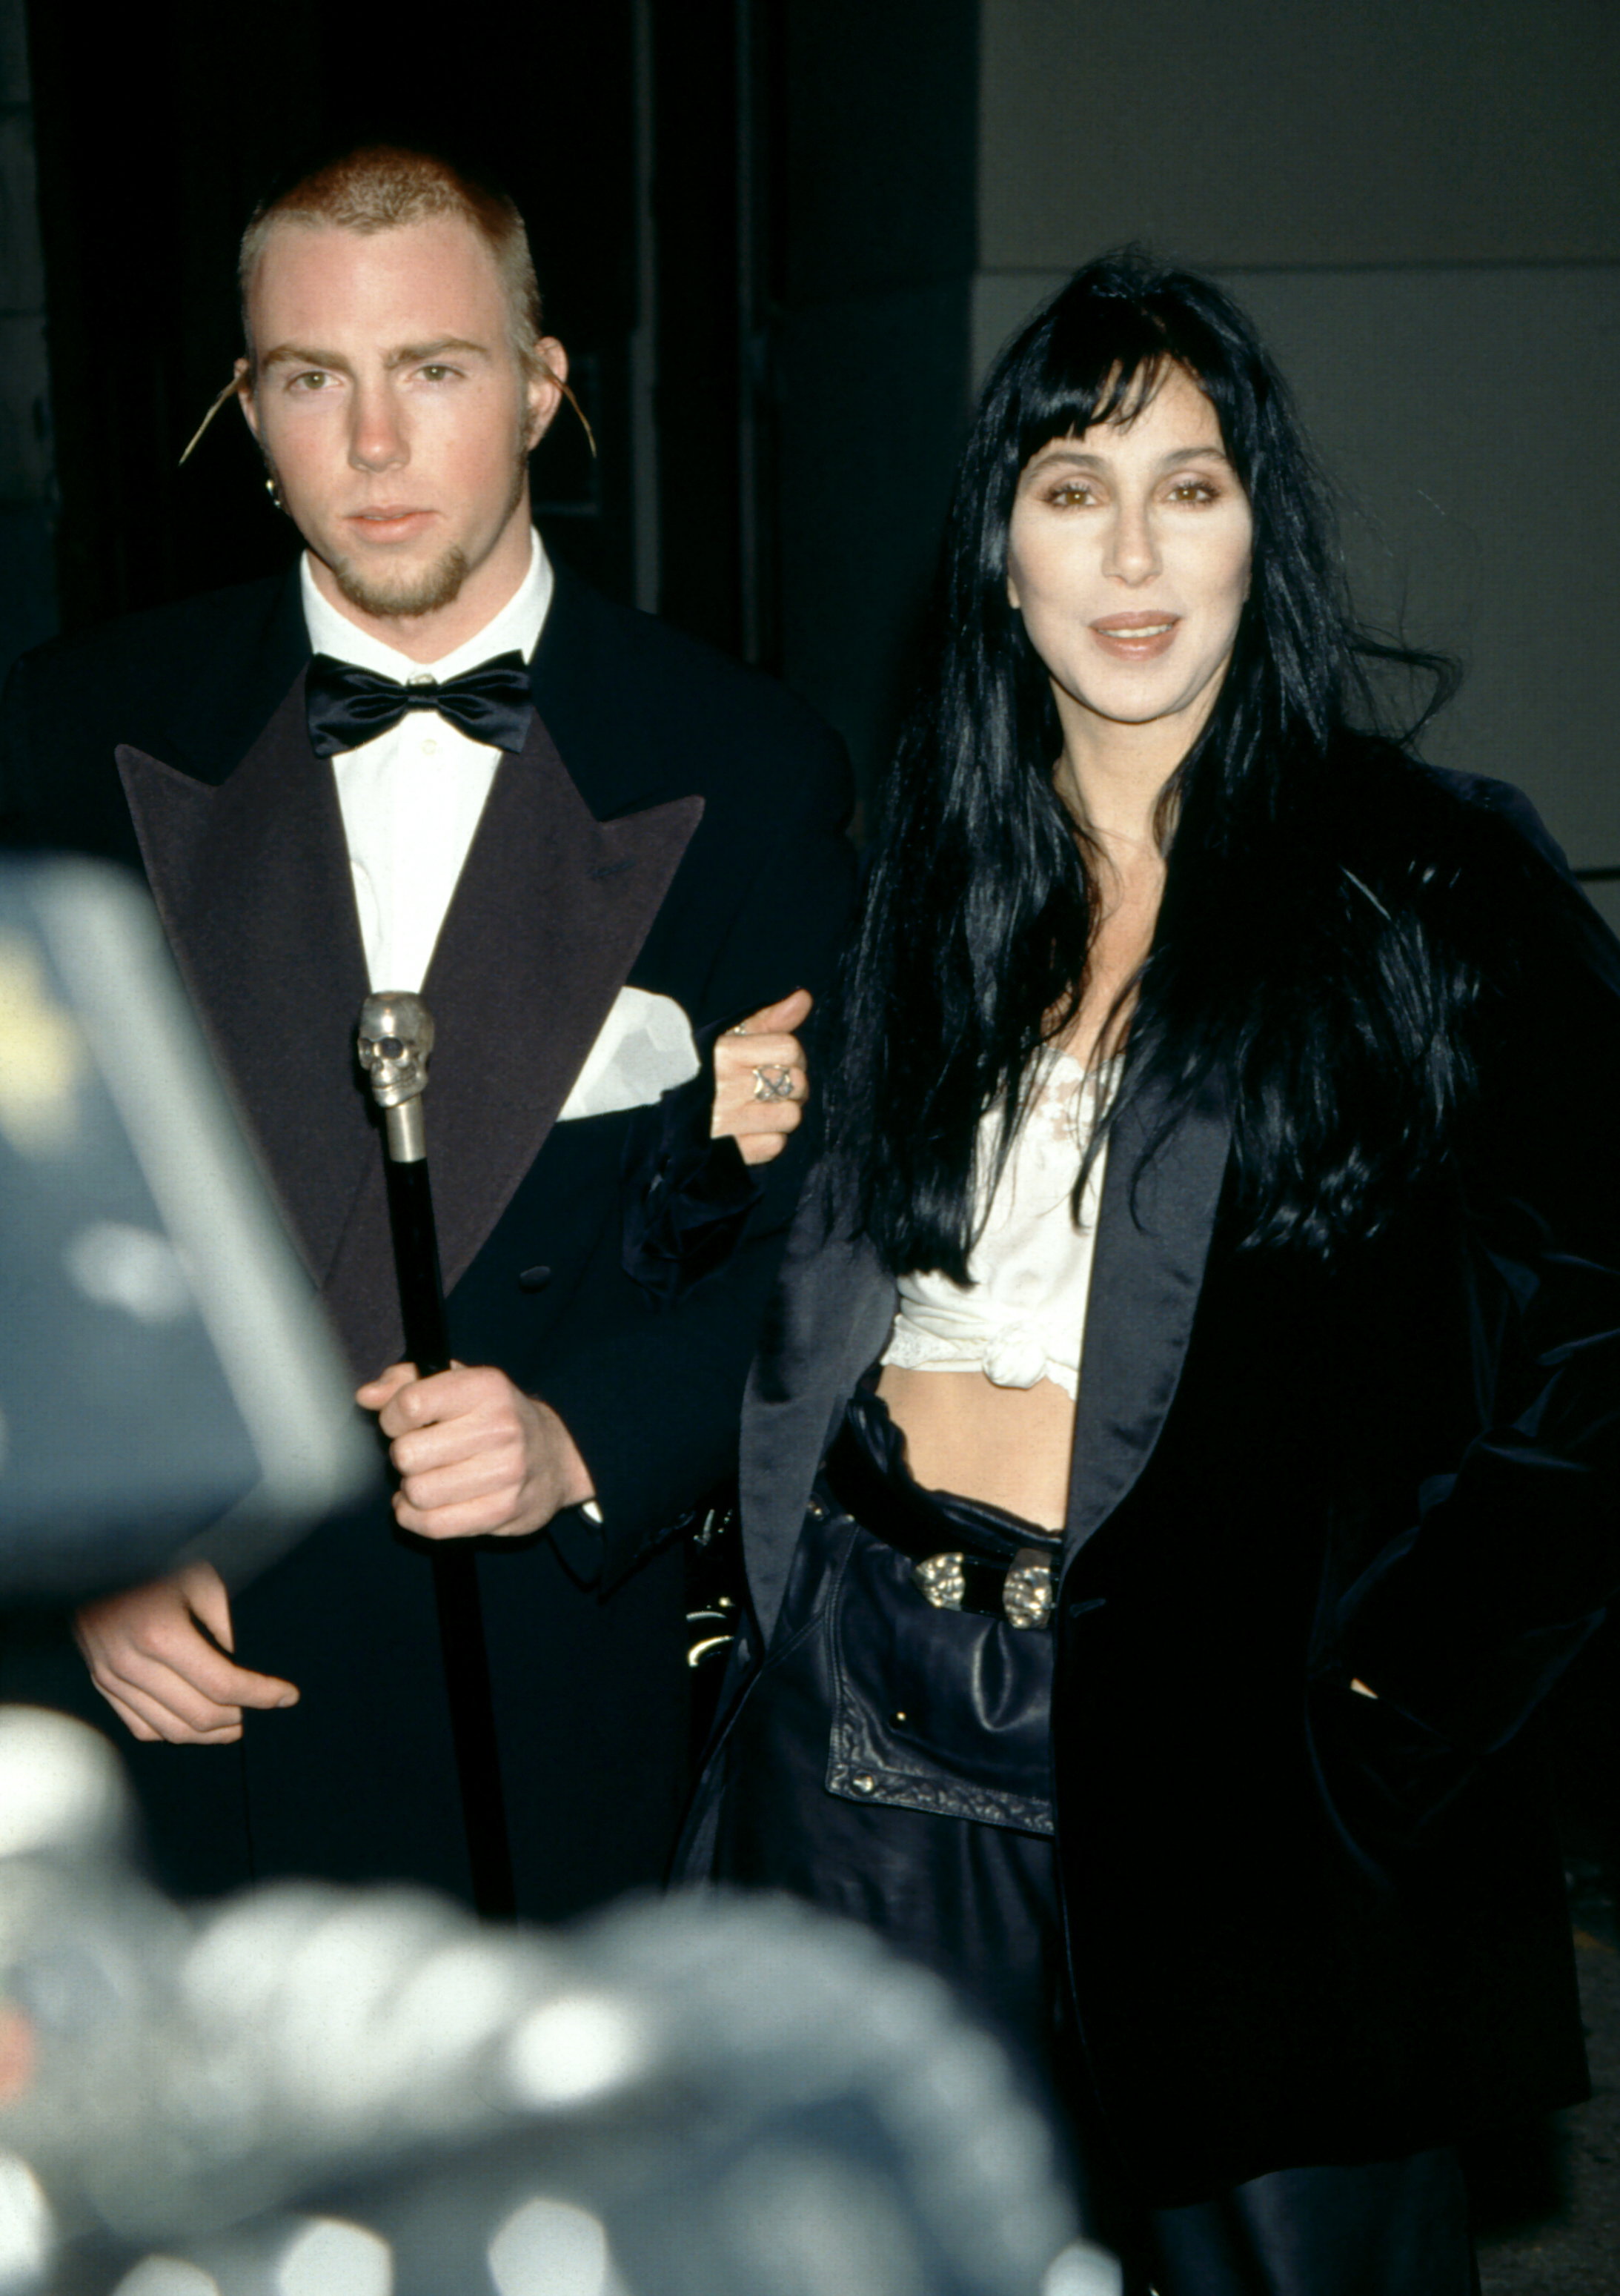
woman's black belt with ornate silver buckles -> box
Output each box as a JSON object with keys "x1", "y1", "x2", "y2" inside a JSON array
[{"x1": 821, "y1": 1398, "x2": 1063, "y2": 1628}]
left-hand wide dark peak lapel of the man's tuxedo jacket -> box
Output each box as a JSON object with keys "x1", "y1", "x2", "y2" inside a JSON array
[{"x1": 117, "y1": 673, "x2": 376, "y2": 1313}]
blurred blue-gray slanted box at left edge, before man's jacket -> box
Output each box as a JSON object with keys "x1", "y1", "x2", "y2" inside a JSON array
[{"x1": 0, "y1": 859, "x2": 376, "y2": 1598}]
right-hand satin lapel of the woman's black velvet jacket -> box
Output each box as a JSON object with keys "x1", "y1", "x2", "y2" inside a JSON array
[{"x1": 1065, "y1": 1069, "x2": 1230, "y2": 1556}]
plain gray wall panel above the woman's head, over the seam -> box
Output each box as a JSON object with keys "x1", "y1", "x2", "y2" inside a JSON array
[{"x1": 980, "y1": 0, "x2": 1620, "y2": 271}]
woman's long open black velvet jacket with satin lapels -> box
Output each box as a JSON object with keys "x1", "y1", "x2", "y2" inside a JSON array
[{"x1": 711, "y1": 780, "x2": 1620, "y2": 2206}]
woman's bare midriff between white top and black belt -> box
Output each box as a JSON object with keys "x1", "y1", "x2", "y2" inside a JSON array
[{"x1": 877, "y1": 1364, "x2": 1074, "y2": 1531}]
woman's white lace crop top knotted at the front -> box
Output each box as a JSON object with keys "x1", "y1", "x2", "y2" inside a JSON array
[{"x1": 883, "y1": 1049, "x2": 1115, "y2": 1396}]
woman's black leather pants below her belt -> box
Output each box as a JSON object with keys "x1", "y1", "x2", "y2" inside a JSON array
[{"x1": 714, "y1": 1396, "x2": 1478, "y2": 2296}]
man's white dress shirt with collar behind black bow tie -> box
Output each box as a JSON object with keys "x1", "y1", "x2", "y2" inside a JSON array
[{"x1": 299, "y1": 528, "x2": 553, "y2": 989}]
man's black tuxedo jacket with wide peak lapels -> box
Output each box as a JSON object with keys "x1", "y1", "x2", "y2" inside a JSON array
[{"x1": 0, "y1": 569, "x2": 852, "y2": 1917}]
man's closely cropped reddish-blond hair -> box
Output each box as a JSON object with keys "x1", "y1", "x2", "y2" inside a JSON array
[{"x1": 236, "y1": 145, "x2": 546, "y2": 376}]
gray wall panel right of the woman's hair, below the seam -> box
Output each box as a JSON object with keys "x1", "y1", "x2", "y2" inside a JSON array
[{"x1": 1230, "y1": 266, "x2": 1620, "y2": 868}]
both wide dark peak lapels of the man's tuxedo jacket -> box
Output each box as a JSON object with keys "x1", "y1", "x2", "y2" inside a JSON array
[{"x1": 119, "y1": 675, "x2": 702, "y2": 1373}]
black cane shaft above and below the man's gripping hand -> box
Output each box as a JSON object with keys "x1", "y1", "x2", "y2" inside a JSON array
[{"x1": 383, "y1": 1134, "x2": 517, "y2": 1922}]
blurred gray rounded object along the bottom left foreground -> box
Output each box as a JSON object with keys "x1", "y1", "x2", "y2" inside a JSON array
[{"x1": 0, "y1": 1708, "x2": 1118, "y2": 2296}]
